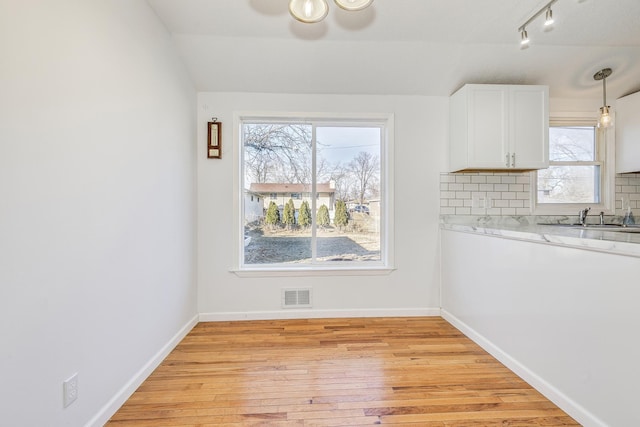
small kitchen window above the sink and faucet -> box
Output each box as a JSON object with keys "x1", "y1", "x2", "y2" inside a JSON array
[{"x1": 532, "y1": 120, "x2": 613, "y2": 215}]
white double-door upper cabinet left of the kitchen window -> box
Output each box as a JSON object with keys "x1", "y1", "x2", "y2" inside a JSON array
[{"x1": 449, "y1": 84, "x2": 549, "y2": 172}]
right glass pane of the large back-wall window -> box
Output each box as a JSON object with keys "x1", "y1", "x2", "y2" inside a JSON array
[{"x1": 316, "y1": 127, "x2": 381, "y2": 262}]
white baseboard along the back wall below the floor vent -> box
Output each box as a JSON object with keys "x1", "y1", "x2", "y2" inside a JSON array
[{"x1": 200, "y1": 308, "x2": 440, "y2": 322}]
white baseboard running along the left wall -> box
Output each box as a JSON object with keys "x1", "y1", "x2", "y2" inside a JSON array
[{"x1": 85, "y1": 315, "x2": 198, "y2": 427}]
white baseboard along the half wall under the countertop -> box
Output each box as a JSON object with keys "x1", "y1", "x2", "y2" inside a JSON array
[{"x1": 441, "y1": 309, "x2": 607, "y2": 427}]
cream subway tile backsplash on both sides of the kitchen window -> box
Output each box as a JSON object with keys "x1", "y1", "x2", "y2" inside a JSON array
[{"x1": 440, "y1": 172, "x2": 640, "y2": 218}]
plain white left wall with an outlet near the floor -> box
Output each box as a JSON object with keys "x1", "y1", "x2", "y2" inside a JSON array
[{"x1": 0, "y1": 0, "x2": 197, "y2": 426}]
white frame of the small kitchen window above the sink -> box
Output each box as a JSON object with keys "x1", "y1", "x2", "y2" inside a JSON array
[{"x1": 530, "y1": 113, "x2": 615, "y2": 217}]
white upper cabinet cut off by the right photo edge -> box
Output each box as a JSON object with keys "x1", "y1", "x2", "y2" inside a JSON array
[{"x1": 615, "y1": 92, "x2": 640, "y2": 173}]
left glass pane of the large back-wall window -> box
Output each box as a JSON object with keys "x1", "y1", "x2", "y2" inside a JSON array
[{"x1": 242, "y1": 123, "x2": 312, "y2": 264}]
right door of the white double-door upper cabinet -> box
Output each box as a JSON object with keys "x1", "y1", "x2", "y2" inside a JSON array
[{"x1": 509, "y1": 86, "x2": 549, "y2": 169}]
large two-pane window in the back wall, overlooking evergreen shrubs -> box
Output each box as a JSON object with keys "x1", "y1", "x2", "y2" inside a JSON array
[{"x1": 238, "y1": 116, "x2": 392, "y2": 271}]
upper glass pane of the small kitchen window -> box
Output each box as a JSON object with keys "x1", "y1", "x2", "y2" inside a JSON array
[{"x1": 549, "y1": 126, "x2": 596, "y2": 162}]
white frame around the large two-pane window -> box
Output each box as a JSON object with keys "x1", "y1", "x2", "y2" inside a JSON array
[{"x1": 230, "y1": 111, "x2": 395, "y2": 277}]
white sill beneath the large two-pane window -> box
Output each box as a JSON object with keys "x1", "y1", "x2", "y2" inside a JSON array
[{"x1": 229, "y1": 267, "x2": 396, "y2": 277}]
